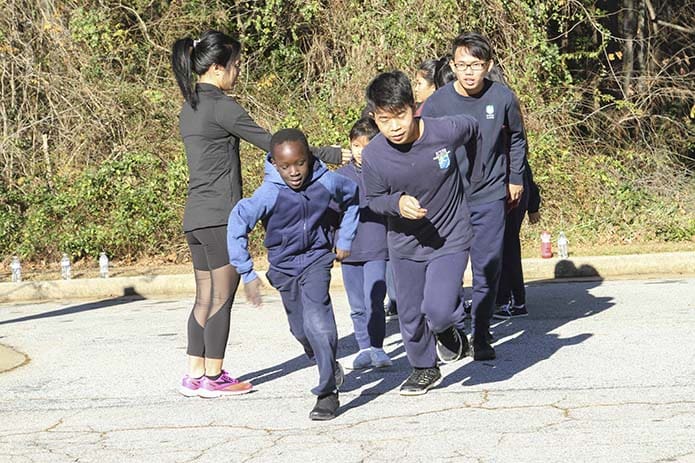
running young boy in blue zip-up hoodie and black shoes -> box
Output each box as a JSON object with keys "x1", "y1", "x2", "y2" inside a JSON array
[{"x1": 227, "y1": 129, "x2": 359, "y2": 420}]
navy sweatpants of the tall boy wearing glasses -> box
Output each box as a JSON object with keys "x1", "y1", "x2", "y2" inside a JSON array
[{"x1": 469, "y1": 199, "x2": 507, "y2": 343}]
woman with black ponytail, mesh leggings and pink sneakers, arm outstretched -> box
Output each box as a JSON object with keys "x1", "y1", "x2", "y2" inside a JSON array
[{"x1": 171, "y1": 31, "x2": 349, "y2": 397}]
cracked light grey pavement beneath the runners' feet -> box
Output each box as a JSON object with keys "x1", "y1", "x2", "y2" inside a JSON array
[{"x1": 0, "y1": 278, "x2": 695, "y2": 463}]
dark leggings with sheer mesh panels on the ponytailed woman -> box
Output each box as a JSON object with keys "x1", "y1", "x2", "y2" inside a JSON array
[{"x1": 186, "y1": 225, "x2": 239, "y2": 359}]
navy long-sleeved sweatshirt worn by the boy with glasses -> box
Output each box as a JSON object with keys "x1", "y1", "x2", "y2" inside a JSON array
[{"x1": 422, "y1": 79, "x2": 526, "y2": 205}]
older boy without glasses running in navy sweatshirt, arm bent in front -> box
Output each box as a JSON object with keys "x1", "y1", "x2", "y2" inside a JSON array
[{"x1": 362, "y1": 71, "x2": 478, "y2": 395}]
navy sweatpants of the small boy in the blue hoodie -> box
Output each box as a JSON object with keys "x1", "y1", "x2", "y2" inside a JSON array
[{"x1": 266, "y1": 253, "x2": 338, "y2": 396}]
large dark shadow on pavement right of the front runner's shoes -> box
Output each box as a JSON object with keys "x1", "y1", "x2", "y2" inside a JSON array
[{"x1": 440, "y1": 260, "x2": 615, "y2": 387}]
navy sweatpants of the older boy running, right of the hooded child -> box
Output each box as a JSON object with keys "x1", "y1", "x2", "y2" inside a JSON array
[{"x1": 391, "y1": 251, "x2": 468, "y2": 368}]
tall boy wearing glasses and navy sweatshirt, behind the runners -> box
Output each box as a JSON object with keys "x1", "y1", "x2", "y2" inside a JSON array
[{"x1": 422, "y1": 32, "x2": 526, "y2": 360}]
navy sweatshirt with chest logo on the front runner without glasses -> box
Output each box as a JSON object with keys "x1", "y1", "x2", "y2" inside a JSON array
[{"x1": 362, "y1": 116, "x2": 478, "y2": 261}]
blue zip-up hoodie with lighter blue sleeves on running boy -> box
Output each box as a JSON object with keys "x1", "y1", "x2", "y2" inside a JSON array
[{"x1": 227, "y1": 154, "x2": 359, "y2": 283}]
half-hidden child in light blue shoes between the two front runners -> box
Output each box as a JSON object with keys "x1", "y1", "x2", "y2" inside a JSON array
[{"x1": 336, "y1": 118, "x2": 391, "y2": 370}]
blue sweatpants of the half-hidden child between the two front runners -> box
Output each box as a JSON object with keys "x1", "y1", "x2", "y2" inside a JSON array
[{"x1": 340, "y1": 260, "x2": 386, "y2": 350}]
